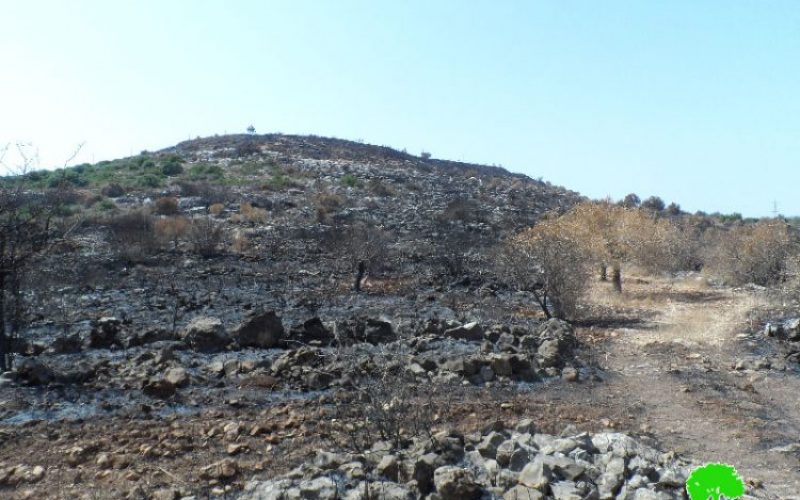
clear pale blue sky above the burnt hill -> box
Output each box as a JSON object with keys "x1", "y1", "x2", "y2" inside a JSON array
[{"x1": 0, "y1": 0, "x2": 800, "y2": 216}]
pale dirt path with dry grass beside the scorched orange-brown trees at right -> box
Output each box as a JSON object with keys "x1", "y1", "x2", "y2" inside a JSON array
[{"x1": 583, "y1": 280, "x2": 800, "y2": 498}]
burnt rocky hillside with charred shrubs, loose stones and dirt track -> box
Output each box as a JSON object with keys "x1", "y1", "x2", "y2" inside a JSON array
[{"x1": 0, "y1": 135, "x2": 800, "y2": 500}]
